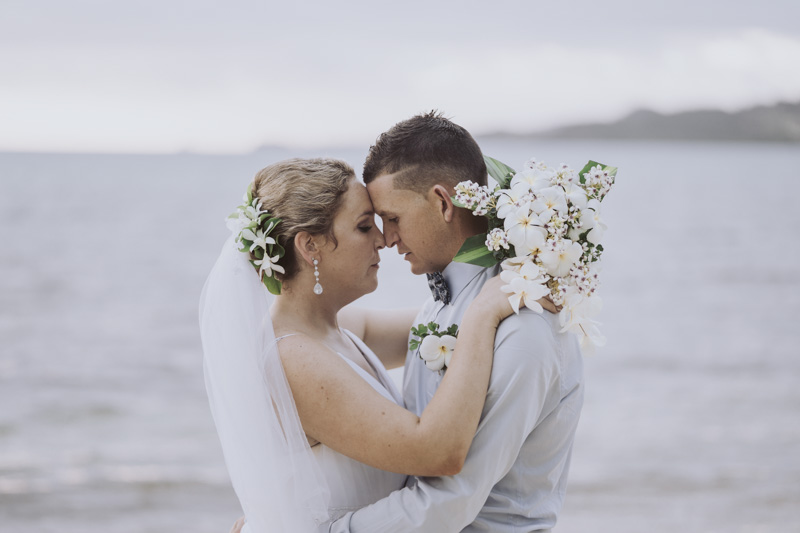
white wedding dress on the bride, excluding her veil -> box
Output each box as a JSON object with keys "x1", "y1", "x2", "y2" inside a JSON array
[{"x1": 304, "y1": 330, "x2": 407, "y2": 520}]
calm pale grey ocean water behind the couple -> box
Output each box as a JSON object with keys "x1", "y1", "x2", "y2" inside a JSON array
[{"x1": 0, "y1": 141, "x2": 800, "y2": 533}]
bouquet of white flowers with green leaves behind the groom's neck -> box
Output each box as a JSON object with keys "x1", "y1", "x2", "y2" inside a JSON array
[{"x1": 453, "y1": 156, "x2": 617, "y2": 350}]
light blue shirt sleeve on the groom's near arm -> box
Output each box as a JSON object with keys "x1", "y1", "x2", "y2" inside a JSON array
[{"x1": 329, "y1": 309, "x2": 560, "y2": 533}]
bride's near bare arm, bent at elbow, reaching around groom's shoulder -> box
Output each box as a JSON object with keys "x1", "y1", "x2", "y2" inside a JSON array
[{"x1": 280, "y1": 278, "x2": 511, "y2": 476}]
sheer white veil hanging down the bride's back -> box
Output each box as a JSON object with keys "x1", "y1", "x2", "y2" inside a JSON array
[{"x1": 200, "y1": 237, "x2": 330, "y2": 533}]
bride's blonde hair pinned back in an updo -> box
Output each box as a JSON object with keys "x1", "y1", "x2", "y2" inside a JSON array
[{"x1": 253, "y1": 158, "x2": 356, "y2": 280}]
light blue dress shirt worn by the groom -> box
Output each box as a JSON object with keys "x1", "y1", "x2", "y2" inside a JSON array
[{"x1": 330, "y1": 263, "x2": 583, "y2": 533}]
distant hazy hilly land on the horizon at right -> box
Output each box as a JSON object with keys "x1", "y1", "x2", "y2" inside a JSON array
[{"x1": 479, "y1": 102, "x2": 800, "y2": 143}]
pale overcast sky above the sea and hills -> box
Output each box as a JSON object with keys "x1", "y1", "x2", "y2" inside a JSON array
[{"x1": 0, "y1": 0, "x2": 800, "y2": 153}]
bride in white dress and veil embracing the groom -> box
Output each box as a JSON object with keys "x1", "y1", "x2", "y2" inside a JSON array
[{"x1": 200, "y1": 159, "x2": 524, "y2": 533}]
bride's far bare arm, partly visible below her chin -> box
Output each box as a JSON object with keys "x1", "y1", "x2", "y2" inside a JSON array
[{"x1": 339, "y1": 306, "x2": 419, "y2": 369}]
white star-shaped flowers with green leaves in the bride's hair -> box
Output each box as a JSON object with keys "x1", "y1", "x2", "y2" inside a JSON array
[{"x1": 227, "y1": 183, "x2": 286, "y2": 294}]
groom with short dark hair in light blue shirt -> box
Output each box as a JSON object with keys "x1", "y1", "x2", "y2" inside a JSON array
[{"x1": 330, "y1": 112, "x2": 583, "y2": 533}]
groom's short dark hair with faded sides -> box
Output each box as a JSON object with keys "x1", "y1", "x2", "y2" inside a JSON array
[{"x1": 362, "y1": 110, "x2": 486, "y2": 195}]
